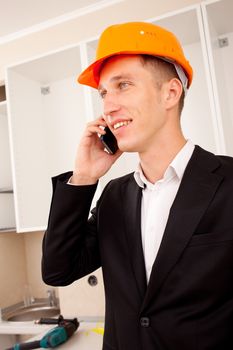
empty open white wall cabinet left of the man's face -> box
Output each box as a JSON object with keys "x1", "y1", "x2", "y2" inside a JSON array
[{"x1": 7, "y1": 46, "x2": 86, "y2": 232}]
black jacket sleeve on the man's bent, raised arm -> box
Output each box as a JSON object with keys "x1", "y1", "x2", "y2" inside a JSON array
[{"x1": 42, "y1": 173, "x2": 101, "y2": 286}]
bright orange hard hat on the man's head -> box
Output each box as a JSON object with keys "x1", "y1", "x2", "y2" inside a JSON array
[{"x1": 78, "y1": 22, "x2": 193, "y2": 88}]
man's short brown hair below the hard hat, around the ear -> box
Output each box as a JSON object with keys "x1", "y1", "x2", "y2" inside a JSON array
[{"x1": 140, "y1": 54, "x2": 185, "y2": 114}]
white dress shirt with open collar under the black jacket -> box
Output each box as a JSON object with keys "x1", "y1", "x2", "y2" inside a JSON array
[{"x1": 134, "y1": 140, "x2": 195, "y2": 283}]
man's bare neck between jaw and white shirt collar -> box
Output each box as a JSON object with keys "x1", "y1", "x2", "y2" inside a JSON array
[{"x1": 139, "y1": 134, "x2": 186, "y2": 183}]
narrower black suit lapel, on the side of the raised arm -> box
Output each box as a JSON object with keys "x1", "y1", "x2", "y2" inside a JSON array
[{"x1": 122, "y1": 177, "x2": 146, "y2": 299}]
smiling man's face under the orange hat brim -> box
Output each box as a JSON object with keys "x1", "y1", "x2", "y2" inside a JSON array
[{"x1": 99, "y1": 55, "x2": 166, "y2": 153}]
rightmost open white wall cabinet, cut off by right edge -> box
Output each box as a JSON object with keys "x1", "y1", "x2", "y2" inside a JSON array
[{"x1": 202, "y1": 0, "x2": 233, "y2": 156}]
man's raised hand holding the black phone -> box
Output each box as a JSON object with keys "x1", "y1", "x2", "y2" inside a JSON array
[{"x1": 71, "y1": 117, "x2": 122, "y2": 185}]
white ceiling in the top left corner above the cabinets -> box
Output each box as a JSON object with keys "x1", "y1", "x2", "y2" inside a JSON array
[{"x1": 0, "y1": 0, "x2": 106, "y2": 39}]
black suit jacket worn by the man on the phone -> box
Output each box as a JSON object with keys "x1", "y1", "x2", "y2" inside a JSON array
[{"x1": 42, "y1": 146, "x2": 233, "y2": 350}]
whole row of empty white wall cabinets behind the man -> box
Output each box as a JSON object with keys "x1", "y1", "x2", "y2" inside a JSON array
[{"x1": 3, "y1": 0, "x2": 233, "y2": 232}]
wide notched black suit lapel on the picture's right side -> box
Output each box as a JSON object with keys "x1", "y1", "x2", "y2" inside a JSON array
[{"x1": 142, "y1": 146, "x2": 222, "y2": 310}]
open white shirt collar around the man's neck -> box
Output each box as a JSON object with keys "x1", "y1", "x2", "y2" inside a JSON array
[{"x1": 134, "y1": 140, "x2": 195, "y2": 188}]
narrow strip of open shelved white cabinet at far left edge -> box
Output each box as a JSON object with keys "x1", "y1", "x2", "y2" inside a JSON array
[{"x1": 0, "y1": 87, "x2": 15, "y2": 232}]
